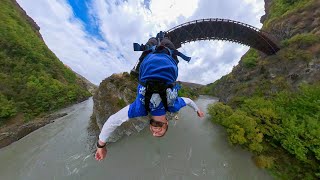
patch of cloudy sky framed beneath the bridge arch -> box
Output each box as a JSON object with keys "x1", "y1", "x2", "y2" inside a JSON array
[{"x1": 178, "y1": 41, "x2": 248, "y2": 84}]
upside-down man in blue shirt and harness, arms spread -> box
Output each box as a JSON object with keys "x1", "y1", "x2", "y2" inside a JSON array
[{"x1": 95, "y1": 32, "x2": 204, "y2": 161}]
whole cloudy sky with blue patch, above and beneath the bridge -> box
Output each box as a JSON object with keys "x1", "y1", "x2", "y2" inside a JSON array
[{"x1": 17, "y1": 0, "x2": 265, "y2": 85}]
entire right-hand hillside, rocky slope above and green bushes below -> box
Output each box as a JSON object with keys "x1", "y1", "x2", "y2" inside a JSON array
[{"x1": 207, "y1": 0, "x2": 320, "y2": 179}]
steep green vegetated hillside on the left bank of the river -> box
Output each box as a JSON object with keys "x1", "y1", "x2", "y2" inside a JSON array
[{"x1": 0, "y1": 0, "x2": 90, "y2": 124}]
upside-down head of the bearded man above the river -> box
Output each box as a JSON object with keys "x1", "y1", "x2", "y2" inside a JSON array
[{"x1": 149, "y1": 115, "x2": 169, "y2": 137}]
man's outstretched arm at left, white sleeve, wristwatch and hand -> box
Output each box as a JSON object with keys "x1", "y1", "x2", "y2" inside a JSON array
[{"x1": 95, "y1": 105, "x2": 130, "y2": 161}]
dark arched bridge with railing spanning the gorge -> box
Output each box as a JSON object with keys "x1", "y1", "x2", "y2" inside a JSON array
[{"x1": 165, "y1": 18, "x2": 280, "y2": 55}]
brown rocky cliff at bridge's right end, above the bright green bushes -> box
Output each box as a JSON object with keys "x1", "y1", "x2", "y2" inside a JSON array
[{"x1": 209, "y1": 0, "x2": 320, "y2": 102}]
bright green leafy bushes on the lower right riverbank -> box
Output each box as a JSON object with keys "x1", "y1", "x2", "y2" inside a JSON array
[{"x1": 209, "y1": 84, "x2": 320, "y2": 179}]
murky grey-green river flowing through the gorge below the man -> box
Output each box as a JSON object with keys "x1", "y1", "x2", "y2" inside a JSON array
[{"x1": 0, "y1": 96, "x2": 272, "y2": 180}]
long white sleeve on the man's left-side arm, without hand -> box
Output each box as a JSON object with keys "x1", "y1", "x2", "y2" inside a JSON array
[{"x1": 99, "y1": 105, "x2": 130, "y2": 142}]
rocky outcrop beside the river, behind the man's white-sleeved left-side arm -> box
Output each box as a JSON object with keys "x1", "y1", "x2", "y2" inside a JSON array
[{"x1": 91, "y1": 73, "x2": 147, "y2": 142}]
